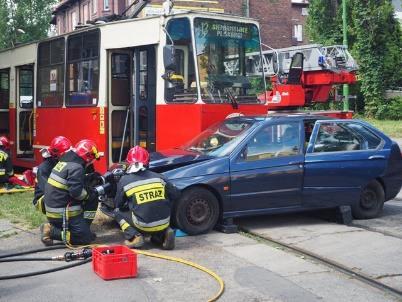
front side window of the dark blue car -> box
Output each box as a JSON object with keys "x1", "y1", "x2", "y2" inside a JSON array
[{"x1": 243, "y1": 123, "x2": 300, "y2": 161}]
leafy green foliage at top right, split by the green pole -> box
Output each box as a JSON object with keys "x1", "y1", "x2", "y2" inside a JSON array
[{"x1": 307, "y1": 0, "x2": 402, "y2": 116}]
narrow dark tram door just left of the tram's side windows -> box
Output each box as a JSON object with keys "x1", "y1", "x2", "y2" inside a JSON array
[{"x1": 16, "y1": 65, "x2": 34, "y2": 158}]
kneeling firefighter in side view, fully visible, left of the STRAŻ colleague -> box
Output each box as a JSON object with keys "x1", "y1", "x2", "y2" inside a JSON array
[{"x1": 41, "y1": 139, "x2": 100, "y2": 245}]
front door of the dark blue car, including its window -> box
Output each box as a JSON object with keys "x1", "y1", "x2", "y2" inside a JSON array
[{"x1": 226, "y1": 121, "x2": 304, "y2": 214}]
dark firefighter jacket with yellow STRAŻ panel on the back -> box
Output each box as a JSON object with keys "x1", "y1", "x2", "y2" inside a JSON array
[{"x1": 115, "y1": 170, "x2": 177, "y2": 232}]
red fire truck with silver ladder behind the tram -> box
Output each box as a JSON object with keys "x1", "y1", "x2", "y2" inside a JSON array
[{"x1": 253, "y1": 44, "x2": 358, "y2": 118}]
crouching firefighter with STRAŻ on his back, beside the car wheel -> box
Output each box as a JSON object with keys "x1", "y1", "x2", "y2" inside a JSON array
[{"x1": 114, "y1": 146, "x2": 178, "y2": 250}]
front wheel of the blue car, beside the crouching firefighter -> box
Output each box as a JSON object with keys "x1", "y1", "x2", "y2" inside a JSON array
[{"x1": 175, "y1": 188, "x2": 219, "y2": 235}]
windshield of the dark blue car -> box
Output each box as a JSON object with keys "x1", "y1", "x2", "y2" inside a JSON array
[{"x1": 182, "y1": 118, "x2": 255, "y2": 157}]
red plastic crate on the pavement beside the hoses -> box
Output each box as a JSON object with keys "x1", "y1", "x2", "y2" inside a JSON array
[{"x1": 92, "y1": 245, "x2": 137, "y2": 280}]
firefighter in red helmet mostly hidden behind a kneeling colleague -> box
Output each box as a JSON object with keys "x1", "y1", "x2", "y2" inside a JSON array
[{"x1": 33, "y1": 136, "x2": 71, "y2": 214}]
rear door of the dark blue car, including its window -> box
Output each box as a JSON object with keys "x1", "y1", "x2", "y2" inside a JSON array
[{"x1": 303, "y1": 120, "x2": 389, "y2": 207}]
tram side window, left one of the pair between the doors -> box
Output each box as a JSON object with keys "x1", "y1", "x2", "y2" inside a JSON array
[{"x1": 37, "y1": 38, "x2": 65, "y2": 107}]
